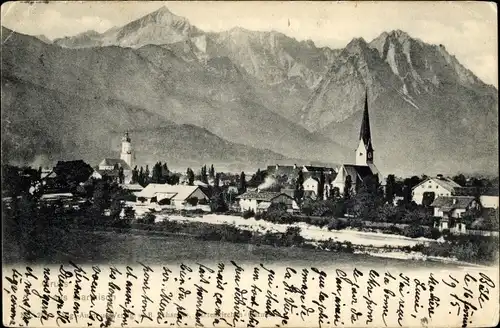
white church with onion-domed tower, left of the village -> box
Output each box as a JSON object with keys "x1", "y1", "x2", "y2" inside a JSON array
[{"x1": 92, "y1": 132, "x2": 135, "y2": 184}]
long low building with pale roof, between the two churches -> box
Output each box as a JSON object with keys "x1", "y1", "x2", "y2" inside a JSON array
[{"x1": 136, "y1": 183, "x2": 210, "y2": 211}]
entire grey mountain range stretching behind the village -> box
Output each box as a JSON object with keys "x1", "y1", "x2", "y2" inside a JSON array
[{"x1": 2, "y1": 7, "x2": 498, "y2": 174}]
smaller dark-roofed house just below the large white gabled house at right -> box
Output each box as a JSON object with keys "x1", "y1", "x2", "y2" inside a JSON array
[{"x1": 431, "y1": 196, "x2": 480, "y2": 218}]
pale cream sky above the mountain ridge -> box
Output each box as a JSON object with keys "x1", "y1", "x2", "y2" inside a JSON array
[{"x1": 1, "y1": 1, "x2": 498, "y2": 88}]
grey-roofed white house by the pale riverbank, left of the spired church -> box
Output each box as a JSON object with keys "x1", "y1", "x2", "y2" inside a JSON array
[{"x1": 237, "y1": 191, "x2": 294, "y2": 213}]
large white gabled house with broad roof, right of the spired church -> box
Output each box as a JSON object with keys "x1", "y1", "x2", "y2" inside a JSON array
[{"x1": 412, "y1": 174, "x2": 462, "y2": 205}]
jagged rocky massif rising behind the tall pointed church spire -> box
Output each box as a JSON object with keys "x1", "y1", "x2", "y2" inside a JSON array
[{"x1": 300, "y1": 31, "x2": 498, "y2": 173}]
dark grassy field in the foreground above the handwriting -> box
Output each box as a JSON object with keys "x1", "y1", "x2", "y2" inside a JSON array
[{"x1": 3, "y1": 226, "x2": 470, "y2": 268}]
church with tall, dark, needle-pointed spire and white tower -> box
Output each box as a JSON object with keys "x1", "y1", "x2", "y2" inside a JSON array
[{"x1": 332, "y1": 92, "x2": 384, "y2": 194}]
